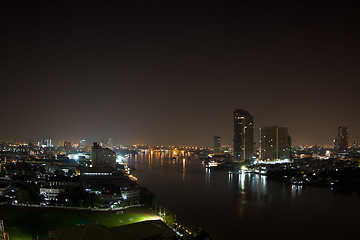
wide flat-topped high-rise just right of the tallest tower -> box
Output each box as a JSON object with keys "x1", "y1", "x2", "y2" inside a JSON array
[{"x1": 259, "y1": 126, "x2": 291, "y2": 161}]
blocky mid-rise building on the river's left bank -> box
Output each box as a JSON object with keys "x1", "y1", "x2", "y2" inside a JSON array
[{"x1": 91, "y1": 142, "x2": 116, "y2": 168}]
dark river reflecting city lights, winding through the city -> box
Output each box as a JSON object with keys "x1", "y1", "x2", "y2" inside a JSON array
[{"x1": 127, "y1": 153, "x2": 360, "y2": 240}]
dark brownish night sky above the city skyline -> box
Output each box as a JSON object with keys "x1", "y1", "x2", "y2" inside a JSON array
[{"x1": 0, "y1": 1, "x2": 360, "y2": 146}]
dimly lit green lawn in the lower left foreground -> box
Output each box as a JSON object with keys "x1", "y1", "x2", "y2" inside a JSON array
[{"x1": 0, "y1": 206, "x2": 158, "y2": 240}]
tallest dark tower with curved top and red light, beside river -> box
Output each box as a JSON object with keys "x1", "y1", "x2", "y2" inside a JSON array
[{"x1": 234, "y1": 109, "x2": 254, "y2": 161}]
